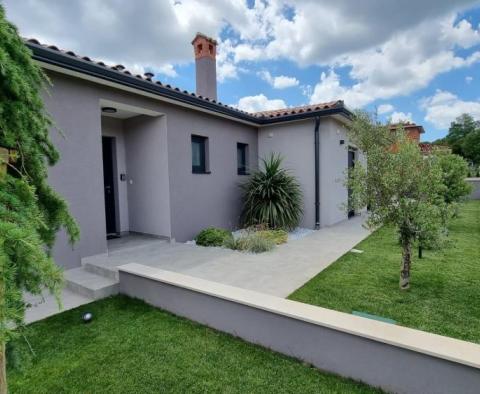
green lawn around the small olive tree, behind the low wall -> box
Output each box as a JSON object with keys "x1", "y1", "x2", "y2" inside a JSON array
[{"x1": 289, "y1": 201, "x2": 480, "y2": 343}]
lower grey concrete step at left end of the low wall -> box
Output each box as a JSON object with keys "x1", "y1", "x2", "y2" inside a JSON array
[{"x1": 64, "y1": 267, "x2": 118, "y2": 300}]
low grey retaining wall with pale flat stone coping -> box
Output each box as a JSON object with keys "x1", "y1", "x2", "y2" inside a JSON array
[{"x1": 119, "y1": 264, "x2": 480, "y2": 394}]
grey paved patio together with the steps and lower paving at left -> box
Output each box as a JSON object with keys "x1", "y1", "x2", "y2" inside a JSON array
[{"x1": 26, "y1": 216, "x2": 369, "y2": 322}]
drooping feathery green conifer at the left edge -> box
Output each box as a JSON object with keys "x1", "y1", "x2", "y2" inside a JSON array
[{"x1": 0, "y1": 6, "x2": 79, "y2": 394}]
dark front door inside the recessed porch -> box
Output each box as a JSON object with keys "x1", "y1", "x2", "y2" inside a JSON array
[{"x1": 102, "y1": 137, "x2": 117, "y2": 238}]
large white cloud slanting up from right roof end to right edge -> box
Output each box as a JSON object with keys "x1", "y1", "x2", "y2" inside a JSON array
[{"x1": 310, "y1": 17, "x2": 480, "y2": 108}]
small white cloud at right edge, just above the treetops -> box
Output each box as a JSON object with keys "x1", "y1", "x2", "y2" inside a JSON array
[{"x1": 421, "y1": 90, "x2": 480, "y2": 129}]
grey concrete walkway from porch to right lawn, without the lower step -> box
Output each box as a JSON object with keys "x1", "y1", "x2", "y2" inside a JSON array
[{"x1": 85, "y1": 216, "x2": 369, "y2": 297}]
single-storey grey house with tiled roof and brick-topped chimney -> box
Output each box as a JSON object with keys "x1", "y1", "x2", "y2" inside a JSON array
[{"x1": 27, "y1": 34, "x2": 358, "y2": 268}]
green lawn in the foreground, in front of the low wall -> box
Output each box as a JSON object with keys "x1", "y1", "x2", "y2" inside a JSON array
[{"x1": 8, "y1": 296, "x2": 379, "y2": 394}]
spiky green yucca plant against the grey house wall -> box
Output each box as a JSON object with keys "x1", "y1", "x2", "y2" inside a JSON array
[{"x1": 241, "y1": 153, "x2": 303, "y2": 230}]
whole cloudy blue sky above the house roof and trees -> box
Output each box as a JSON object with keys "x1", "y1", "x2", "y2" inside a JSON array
[{"x1": 0, "y1": 0, "x2": 480, "y2": 140}]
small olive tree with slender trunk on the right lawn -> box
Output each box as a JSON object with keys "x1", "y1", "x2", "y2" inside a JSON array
[{"x1": 346, "y1": 112, "x2": 446, "y2": 289}]
